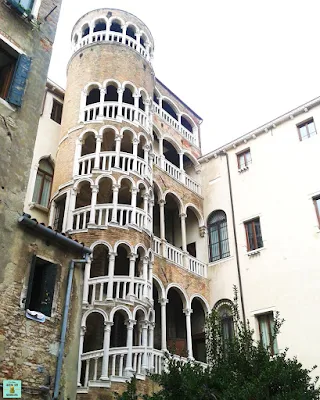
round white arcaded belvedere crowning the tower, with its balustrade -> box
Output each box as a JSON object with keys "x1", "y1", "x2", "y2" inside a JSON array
[{"x1": 71, "y1": 8, "x2": 154, "y2": 62}]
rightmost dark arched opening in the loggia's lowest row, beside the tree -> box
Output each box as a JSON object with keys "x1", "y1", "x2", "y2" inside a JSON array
[{"x1": 191, "y1": 298, "x2": 206, "y2": 362}]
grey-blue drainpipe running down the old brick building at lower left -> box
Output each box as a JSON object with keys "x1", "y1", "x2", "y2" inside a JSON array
[{"x1": 52, "y1": 254, "x2": 88, "y2": 400}]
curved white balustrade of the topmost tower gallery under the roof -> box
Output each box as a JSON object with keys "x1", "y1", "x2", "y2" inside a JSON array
[{"x1": 74, "y1": 31, "x2": 150, "y2": 61}]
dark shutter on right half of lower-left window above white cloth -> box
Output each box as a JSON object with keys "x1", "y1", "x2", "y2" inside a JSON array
[{"x1": 39, "y1": 263, "x2": 57, "y2": 317}]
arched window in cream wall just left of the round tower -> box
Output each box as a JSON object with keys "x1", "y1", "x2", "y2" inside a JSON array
[{"x1": 32, "y1": 159, "x2": 53, "y2": 207}]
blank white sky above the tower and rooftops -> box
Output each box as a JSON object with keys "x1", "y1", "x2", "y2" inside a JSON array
[{"x1": 49, "y1": 0, "x2": 320, "y2": 153}]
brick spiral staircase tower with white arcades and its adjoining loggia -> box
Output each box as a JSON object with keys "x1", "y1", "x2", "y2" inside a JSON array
[{"x1": 50, "y1": 9, "x2": 208, "y2": 398}]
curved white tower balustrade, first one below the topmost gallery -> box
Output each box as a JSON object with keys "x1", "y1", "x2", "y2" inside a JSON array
[{"x1": 80, "y1": 101, "x2": 149, "y2": 130}]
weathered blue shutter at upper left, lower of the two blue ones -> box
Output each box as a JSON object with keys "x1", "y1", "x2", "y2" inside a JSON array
[{"x1": 7, "y1": 54, "x2": 31, "y2": 107}]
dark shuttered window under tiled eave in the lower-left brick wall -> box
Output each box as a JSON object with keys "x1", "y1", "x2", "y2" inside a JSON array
[{"x1": 26, "y1": 256, "x2": 57, "y2": 317}]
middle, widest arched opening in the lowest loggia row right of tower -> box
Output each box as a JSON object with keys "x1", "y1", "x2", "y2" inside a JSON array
[{"x1": 166, "y1": 288, "x2": 187, "y2": 357}]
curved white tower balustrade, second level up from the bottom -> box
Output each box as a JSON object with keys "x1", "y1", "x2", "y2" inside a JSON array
[{"x1": 84, "y1": 276, "x2": 151, "y2": 305}]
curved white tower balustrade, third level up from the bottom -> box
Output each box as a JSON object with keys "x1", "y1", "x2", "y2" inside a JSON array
[{"x1": 72, "y1": 204, "x2": 152, "y2": 232}]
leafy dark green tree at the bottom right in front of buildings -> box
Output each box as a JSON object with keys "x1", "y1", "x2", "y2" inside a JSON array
[{"x1": 121, "y1": 290, "x2": 320, "y2": 400}]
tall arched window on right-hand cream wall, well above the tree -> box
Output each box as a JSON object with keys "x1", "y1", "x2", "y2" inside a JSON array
[{"x1": 208, "y1": 210, "x2": 230, "y2": 262}]
